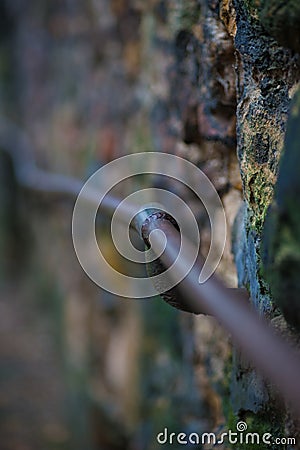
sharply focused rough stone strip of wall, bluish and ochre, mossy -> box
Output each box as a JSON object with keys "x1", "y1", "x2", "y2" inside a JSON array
[{"x1": 232, "y1": 1, "x2": 299, "y2": 440}]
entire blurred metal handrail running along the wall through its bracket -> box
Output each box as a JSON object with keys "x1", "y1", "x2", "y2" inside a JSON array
[{"x1": 0, "y1": 121, "x2": 300, "y2": 417}]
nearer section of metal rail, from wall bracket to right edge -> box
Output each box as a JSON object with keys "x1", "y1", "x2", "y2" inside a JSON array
[{"x1": 142, "y1": 214, "x2": 300, "y2": 416}]
